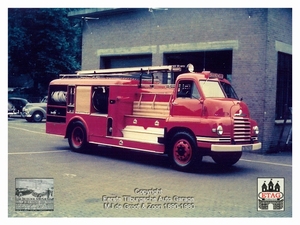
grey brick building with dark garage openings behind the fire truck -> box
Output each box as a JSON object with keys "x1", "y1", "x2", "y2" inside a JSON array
[{"x1": 69, "y1": 8, "x2": 292, "y2": 153}]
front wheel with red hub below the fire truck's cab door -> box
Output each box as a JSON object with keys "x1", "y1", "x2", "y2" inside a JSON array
[{"x1": 169, "y1": 132, "x2": 202, "y2": 171}]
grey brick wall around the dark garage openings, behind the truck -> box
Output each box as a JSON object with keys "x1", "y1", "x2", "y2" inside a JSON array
[{"x1": 78, "y1": 8, "x2": 292, "y2": 152}]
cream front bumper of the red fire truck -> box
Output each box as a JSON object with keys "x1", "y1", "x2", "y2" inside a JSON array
[{"x1": 211, "y1": 142, "x2": 261, "y2": 152}]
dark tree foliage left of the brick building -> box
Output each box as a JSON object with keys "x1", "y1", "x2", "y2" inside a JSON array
[{"x1": 8, "y1": 8, "x2": 81, "y2": 92}]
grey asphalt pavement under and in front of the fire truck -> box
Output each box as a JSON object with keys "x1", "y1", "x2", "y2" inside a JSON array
[{"x1": 8, "y1": 120, "x2": 295, "y2": 221}]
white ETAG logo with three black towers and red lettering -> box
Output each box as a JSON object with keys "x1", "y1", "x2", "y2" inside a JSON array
[{"x1": 257, "y1": 178, "x2": 284, "y2": 211}]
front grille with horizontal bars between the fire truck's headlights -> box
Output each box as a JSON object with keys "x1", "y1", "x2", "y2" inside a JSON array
[{"x1": 233, "y1": 116, "x2": 251, "y2": 142}]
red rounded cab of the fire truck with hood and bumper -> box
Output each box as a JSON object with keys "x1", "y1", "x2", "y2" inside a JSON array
[{"x1": 164, "y1": 71, "x2": 261, "y2": 170}]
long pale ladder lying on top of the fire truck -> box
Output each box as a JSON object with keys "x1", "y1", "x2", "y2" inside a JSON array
[{"x1": 59, "y1": 65, "x2": 185, "y2": 87}]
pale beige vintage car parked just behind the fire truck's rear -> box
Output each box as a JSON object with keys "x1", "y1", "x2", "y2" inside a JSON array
[{"x1": 22, "y1": 97, "x2": 47, "y2": 122}]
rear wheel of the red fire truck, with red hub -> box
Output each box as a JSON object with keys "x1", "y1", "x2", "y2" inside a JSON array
[{"x1": 68, "y1": 121, "x2": 87, "y2": 152}]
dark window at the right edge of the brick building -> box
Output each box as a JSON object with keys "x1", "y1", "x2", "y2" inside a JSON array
[{"x1": 276, "y1": 52, "x2": 292, "y2": 119}]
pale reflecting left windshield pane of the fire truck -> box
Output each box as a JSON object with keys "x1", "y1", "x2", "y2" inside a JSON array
[{"x1": 199, "y1": 80, "x2": 225, "y2": 98}]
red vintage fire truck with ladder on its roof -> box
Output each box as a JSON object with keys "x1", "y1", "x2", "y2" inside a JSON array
[{"x1": 46, "y1": 64, "x2": 261, "y2": 171}]
